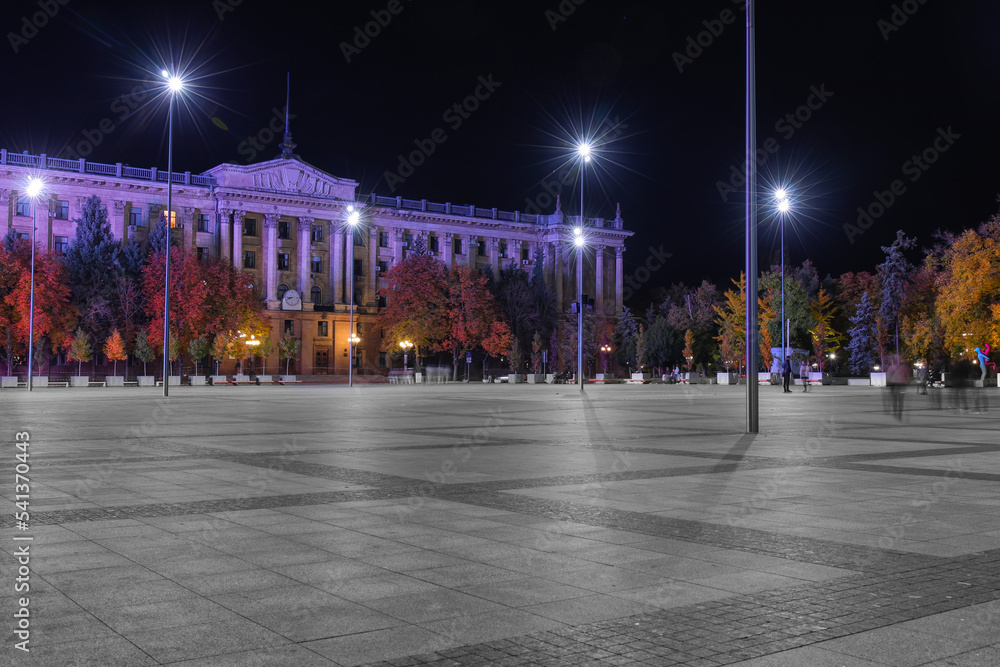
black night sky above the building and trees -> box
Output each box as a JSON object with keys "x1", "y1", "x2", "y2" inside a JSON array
[{"x1": 0, "y1": 0, "x2": 1000, "y2": 300}]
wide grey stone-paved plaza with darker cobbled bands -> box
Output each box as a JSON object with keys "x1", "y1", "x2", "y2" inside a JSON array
[{"x1": 0, "y1": 384, "x2": 1000, "y2": 667}]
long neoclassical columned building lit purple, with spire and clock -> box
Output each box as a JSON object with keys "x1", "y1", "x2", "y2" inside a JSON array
[{"x1": 0, "y1": 145, "x2": 632, "y2": 374}]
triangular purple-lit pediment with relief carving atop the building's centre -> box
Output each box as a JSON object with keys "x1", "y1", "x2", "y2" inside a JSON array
[{"x1": 206, "y1": 158, "x2": 358, "y2": 199}]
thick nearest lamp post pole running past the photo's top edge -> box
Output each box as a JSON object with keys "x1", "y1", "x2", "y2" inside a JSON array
[{"x1": 746, "y1": 0, "x2": 758, "y2": 433}]
